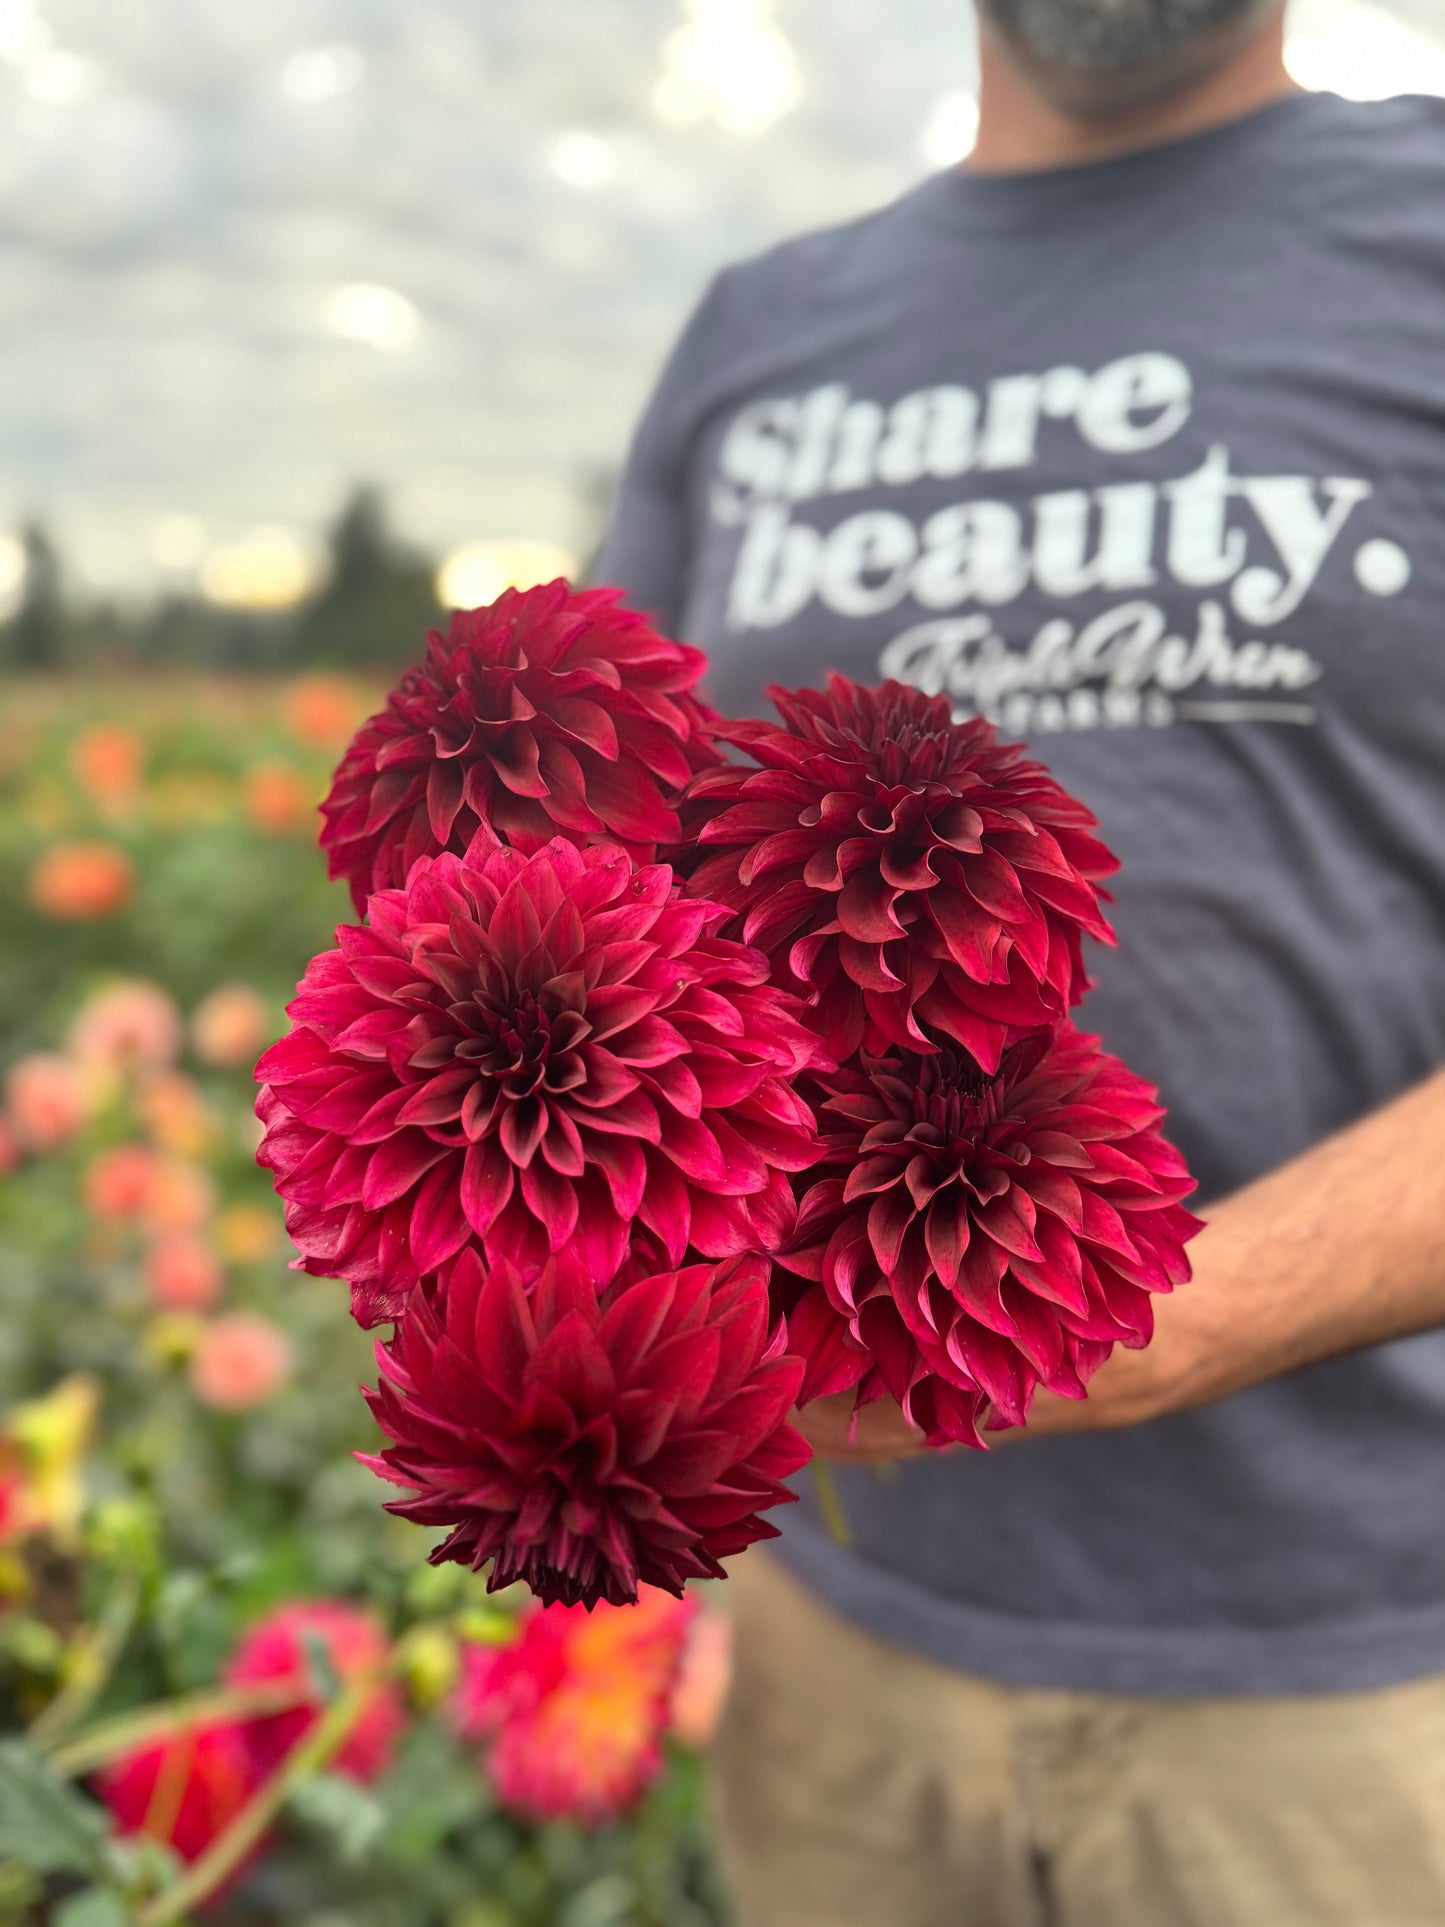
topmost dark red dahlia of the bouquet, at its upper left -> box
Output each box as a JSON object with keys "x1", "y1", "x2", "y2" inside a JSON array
[{"x1": 322, "y1": 580, "x2": 719, "y2": 915}]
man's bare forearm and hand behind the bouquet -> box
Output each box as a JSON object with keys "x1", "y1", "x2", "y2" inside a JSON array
[{"x1": 798, "y1": 1071, "x2": 1445, "y2": 1461}]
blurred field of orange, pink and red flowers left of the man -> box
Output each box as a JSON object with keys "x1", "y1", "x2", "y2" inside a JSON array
[{"x1": 0, "y1": 674, "x2": 726, "y2": 1927}]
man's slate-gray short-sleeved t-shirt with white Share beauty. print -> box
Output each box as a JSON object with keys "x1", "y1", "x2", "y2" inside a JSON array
[{"x1": 597, "y1": 96, "x2": 1445, "y2": 1694}]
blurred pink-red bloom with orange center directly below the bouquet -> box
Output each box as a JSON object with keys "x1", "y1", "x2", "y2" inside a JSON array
[{"x1": 453, "y1": 1586, "x2": 696, "y2": 1827}]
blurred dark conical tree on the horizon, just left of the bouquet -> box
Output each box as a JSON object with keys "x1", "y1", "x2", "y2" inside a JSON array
[{"x1": 293, "y1": 488, "x2": 441, "y2": 669}]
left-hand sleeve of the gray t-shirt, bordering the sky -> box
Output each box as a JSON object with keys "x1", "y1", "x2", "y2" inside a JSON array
[{"x1": 590, "y1": 276, "x2": 723, "y2": 632}]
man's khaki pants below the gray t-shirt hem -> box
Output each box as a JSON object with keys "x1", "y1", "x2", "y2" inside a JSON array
[{"x1": 715, "y1": 1549, "x2": 1445, "y2": 1927}]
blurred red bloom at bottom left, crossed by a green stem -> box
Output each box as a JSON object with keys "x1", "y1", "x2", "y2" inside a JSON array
[{"x1": 96, "y1": 1721, "x2": 266, "y2": 1871}]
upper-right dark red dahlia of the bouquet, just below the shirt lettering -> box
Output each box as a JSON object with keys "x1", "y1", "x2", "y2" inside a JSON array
[{"x1": 684, "y1": 676, "x2": 1117, "y2": 1071}]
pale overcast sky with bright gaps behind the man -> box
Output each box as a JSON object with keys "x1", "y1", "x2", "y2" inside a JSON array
[{"x1": 0, "y1": 0, "x2": 1445, "y2": 590}]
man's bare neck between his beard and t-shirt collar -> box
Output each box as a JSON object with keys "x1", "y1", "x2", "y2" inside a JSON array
[{"x1": 965, "y1": 19, "x2": 1297, "y2": 173}]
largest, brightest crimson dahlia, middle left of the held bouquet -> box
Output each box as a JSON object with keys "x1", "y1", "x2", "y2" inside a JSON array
[{"x1": 256, "y1": 831, "x2": 817, "y2": 1324}]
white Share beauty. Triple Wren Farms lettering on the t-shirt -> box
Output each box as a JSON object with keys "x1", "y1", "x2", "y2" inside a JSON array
[{"x1": 711, "y1": 353, "x2": 1410, "y2": 734}]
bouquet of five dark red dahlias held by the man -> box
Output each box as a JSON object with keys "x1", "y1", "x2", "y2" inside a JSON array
[{"x1": 256, "y1": 582, "x2": 1195, "y2": 1605}]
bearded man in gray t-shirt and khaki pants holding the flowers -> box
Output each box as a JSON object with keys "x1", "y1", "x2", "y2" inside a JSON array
[{"x1": 599, "y1": 0, "x2": 1445, "y2": 1927}]
